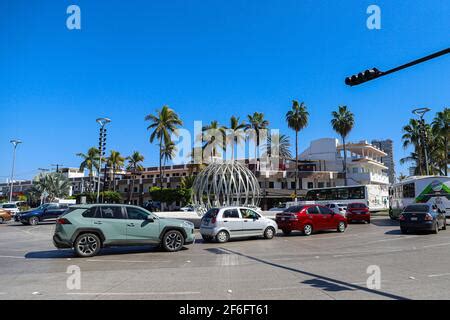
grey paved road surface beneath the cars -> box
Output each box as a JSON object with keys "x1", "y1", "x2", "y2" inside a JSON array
[{"x1": 0, "y1": 217, "x2": 450, "y2": 300}]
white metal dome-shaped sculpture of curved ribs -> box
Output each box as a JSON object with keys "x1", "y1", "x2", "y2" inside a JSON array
[{"x1": 192, "y1": 159, "x2": 260, "y2": 209}]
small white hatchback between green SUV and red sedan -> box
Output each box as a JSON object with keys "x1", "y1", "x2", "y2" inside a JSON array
[{"x1": 200, "y1": 207, "x2": 277, "y2": 243}]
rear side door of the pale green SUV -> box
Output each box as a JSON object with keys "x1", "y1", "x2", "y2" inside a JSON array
[{"x1": 92, "y1": 206, "x2": 127, "y2": 244}]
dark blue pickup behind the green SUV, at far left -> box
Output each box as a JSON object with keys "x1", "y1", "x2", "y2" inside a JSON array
[{"x1": 14, "y1": 203, "x2": 69, "y2": 226}]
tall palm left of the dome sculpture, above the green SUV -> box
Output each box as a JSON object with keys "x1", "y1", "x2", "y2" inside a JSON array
[{"x1": 145, "y1": 105, "x2": 183, "y2": 189}]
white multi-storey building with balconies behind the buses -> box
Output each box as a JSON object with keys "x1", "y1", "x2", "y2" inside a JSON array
[{"x1": 299, "y1": 138, "x2": 389, "y2": 185}]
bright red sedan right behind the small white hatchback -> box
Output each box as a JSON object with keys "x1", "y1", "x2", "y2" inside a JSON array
[{"x1": 275, "y1": 205, "x2": 347, "y2": 236}]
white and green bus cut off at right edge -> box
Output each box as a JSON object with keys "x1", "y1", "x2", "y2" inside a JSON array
[{"x1": 389, "y1": 176, "x2": 450, "y2": 219}]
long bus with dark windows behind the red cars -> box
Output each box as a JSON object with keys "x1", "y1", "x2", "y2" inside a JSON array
[{"x1": 286, "y1": 184, "x2": 389, "y2": 212}]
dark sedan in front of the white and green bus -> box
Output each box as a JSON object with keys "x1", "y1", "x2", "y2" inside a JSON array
[{"x1": 398, "y1": 203, "x2": 447, "y2": 233}]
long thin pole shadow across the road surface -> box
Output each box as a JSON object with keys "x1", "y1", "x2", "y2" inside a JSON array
[{"x1": 221, "y1": 248, "x2": 410, "y2": 300}]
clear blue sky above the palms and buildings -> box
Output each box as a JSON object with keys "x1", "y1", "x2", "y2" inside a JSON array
[{"x1": 0, "y1": 0, "x2": 450, "y2": 181}]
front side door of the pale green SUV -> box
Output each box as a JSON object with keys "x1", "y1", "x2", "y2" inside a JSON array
[{"x1": 125, "y1": 207, "x2": 160, "y2": 243}]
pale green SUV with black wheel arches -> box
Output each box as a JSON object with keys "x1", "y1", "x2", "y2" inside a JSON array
[{"x1": 53, "y1": 204, "x2": 195, "y2": 257}]
